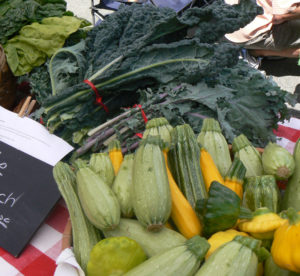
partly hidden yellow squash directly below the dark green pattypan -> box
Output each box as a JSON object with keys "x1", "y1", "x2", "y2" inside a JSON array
[{"x1": 205, "y1": 229, "x2": 249, "y2": 260}]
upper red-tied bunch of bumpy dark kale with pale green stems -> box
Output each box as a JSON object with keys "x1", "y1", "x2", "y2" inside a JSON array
[{"x1": 35, "y1": 0, "x2": 261, "y2": 141}]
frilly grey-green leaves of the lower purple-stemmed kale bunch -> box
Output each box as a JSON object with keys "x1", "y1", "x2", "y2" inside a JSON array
[{"x1": 151, "y1": 61, "x2": 296, "y2": 147}]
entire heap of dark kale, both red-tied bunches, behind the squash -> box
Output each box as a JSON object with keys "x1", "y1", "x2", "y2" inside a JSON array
[{"x1": 27, "y1": 0, "x2": 295, "y2": 149}]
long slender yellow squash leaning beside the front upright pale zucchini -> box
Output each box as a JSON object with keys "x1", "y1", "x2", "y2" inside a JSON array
[{"x1": 163, "y1": 151, "x2": 202, "y2": 239}]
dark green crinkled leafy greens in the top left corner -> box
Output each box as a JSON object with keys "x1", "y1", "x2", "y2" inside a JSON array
[{"x1": 0, "y1": 0, "x2": 72, "y2": 44}]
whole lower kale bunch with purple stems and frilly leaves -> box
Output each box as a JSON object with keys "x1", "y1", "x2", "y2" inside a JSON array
[{"x1": 76, "y1": 61, "x2": 295, "y2": 160}]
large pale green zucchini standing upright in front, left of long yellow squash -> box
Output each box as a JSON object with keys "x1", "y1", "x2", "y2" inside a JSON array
[{"x1": 132, "y1": 136, "x2": 172, "y2": 231}]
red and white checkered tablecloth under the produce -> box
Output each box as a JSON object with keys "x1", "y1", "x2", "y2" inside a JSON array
[{"x1": 0, "y1": 118, "x2": 300, "y2": 276}]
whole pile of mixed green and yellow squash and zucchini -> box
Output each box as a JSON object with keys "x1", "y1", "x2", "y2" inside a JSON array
[{"x1": 53, "y1": 118, "x2": 300, "y2": 276}]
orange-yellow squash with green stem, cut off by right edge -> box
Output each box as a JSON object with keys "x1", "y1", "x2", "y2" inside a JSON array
[{"x1": 271, "y1": 208, "x2": 300, "y2": 273}]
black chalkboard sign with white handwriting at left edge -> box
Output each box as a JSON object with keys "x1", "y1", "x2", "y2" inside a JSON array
[{"x1": 0, "y1": 141, "x2": 60, "y2": 257}]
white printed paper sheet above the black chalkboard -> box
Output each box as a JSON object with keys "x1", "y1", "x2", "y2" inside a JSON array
[{"x1": 0, "y1": 106, "x2": 73, "y2": 166}]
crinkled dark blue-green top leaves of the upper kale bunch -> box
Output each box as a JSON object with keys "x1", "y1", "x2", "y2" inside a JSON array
[{"x1": 82, "y1": 0, "x2": 261, "y2": 82}]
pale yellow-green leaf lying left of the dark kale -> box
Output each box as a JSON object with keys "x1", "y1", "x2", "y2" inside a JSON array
[{"x1": 4, "y1": 16, "x2": 81, "y2": 76}]
